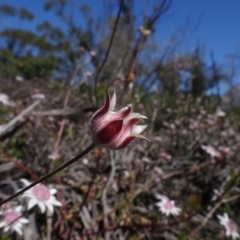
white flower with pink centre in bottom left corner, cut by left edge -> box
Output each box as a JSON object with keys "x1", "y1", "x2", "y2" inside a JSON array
[{"x1": 0, "y1": 206, "x2": 29, "y2": 236}]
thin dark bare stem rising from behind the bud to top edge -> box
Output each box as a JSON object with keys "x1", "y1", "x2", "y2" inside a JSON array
[{"x1": 94, "y1": 0, "x2": 124, "y2": 105}]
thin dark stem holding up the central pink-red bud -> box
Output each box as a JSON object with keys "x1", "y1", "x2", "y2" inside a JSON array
[{"x1": 0, "y1": 143, "x2": 96, "y2": 206}]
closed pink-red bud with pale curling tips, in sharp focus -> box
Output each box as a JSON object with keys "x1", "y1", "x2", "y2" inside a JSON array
[{"x1": 90, "y1": 93, "x2": 149, "y2": 149}]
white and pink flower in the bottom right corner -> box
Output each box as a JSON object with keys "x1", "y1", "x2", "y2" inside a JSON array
[{"x1": 217, "y1": 213, "x2": 240, "y2": 240}]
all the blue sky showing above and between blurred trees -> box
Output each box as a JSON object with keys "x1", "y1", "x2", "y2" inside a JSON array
[{"x1": 0, "y1": 0, "x2": 240, "y2": 90}]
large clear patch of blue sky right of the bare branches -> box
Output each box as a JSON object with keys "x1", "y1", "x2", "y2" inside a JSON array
[{"x1": 165, "y1": 0, "x2": 240, "y2": 62}]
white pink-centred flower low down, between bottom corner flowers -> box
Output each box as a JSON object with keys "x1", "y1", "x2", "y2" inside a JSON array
[{"x1": 156, "y1": 194, "x2": 181, "y2": 216}]
